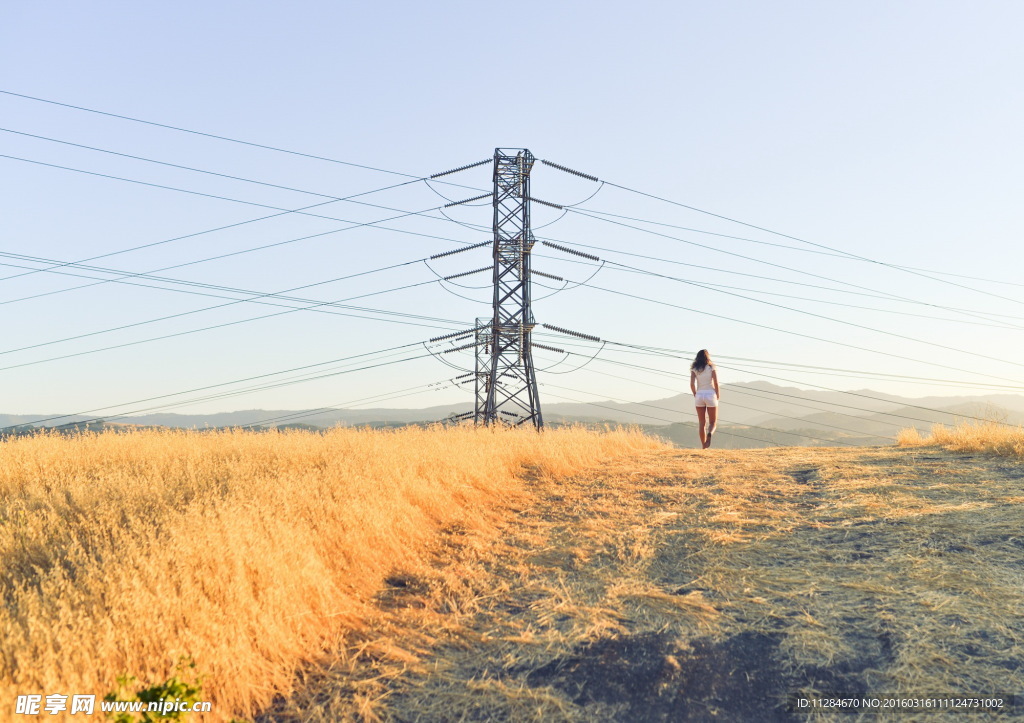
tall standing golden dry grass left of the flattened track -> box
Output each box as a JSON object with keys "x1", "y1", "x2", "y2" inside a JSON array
[{"x1": 0, "y1": 421, "x2": 660, "y2": 718}]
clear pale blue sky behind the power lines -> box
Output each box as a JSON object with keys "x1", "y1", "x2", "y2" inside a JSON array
[{"x1": 0, "y1": 0, "x2": 1024, "y2": 416}]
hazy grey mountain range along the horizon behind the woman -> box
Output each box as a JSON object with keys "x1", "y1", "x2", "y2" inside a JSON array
[{"x1": 0, "y1": 382, "x2": 1024, "y2": 448}]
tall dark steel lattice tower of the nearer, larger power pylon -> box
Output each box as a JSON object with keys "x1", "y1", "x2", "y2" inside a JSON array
[{"x1": 476, "y1": 148, "x2": 544, "y2": 429}]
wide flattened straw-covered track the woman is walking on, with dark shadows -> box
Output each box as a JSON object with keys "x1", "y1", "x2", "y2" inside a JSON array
[{"x1": 263, "y1": 448, "x2": 1024, "y2": 721}]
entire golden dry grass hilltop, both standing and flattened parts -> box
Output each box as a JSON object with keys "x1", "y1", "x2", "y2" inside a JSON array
[{"x1": 0, "y1": 429, "x2": 1024, "y2": 721}]
